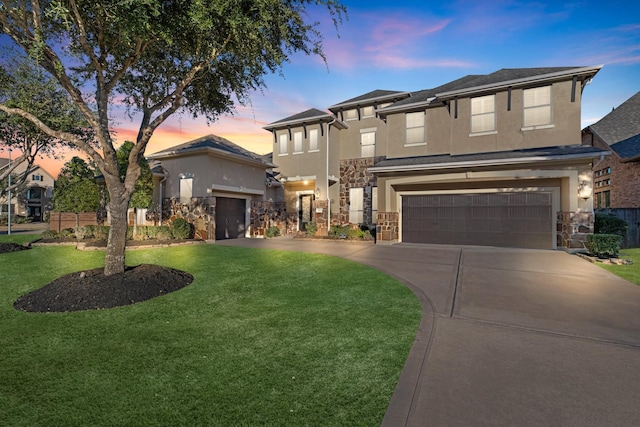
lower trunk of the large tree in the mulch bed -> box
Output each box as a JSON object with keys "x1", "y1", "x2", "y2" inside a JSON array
[{"x1": 104, "y1": 200, "x2": 129, "y2": 276}]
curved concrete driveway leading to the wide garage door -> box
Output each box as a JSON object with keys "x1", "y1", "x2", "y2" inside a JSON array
[{"x1": 217, "y1": 238, "x2": 640, "y2": 426}]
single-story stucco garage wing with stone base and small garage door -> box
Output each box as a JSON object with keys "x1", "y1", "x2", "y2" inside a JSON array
[{"x1": 147, "y1": 135, "x2": 282, "y2": 240}]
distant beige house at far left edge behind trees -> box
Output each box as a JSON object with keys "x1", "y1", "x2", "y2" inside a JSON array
[{"x1": 0, "y1": 158, "x2": 55, "y2": 222}]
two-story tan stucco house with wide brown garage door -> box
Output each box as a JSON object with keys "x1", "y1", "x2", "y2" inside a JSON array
[{"x1": 265, "y1": 66, "x2": 606, "y2": 248}]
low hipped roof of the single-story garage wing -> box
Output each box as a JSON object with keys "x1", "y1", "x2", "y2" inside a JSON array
[{"x1": 146, "y1": 135, "x2": 274, "y2": 168}]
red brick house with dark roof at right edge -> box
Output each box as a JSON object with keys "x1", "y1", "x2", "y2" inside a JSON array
[{"x1": 582, "y1": 92, "x2": 640, "y2": 208}]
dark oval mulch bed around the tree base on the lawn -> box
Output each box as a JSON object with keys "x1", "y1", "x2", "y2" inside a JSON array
[{"x1": 13, "y1": 264, "x2": 193, "y2": 313}]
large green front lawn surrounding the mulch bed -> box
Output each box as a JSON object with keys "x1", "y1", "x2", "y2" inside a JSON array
[{"x1": 0, "y1": 236, "x2": 421, "y2": 426}]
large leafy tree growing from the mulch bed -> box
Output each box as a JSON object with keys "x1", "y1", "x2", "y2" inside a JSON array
[{"x1": 0, "y1": 0, "x2": 345, "y2": 275}]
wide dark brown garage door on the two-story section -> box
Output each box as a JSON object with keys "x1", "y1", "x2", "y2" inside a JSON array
[{"x1": 402, "y1": 192, "x2": 553, "y2": 249}]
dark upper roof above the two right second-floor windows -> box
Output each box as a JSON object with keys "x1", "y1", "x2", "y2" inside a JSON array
[{"x1": 379, "y1": 65, "x2": 602, "y2": 115}]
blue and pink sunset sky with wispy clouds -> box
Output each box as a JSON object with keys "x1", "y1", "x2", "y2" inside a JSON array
[{"x1": 0, "y1": 0, "x2": 640, "y2": 176}]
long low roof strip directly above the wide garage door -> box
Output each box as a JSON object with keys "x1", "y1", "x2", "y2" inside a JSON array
[{"x1": 369, "y1": 145, "x2": 609, "y2": 172}]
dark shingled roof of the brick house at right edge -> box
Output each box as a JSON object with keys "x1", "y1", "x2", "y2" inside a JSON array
[{"x1": 589, "y1": 92, "x2": 640, "y2": 160}]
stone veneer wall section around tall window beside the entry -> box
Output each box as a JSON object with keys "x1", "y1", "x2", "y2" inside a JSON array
[{"x1": 337, "y1": 157, "x2": 385, "y2": 225}]
